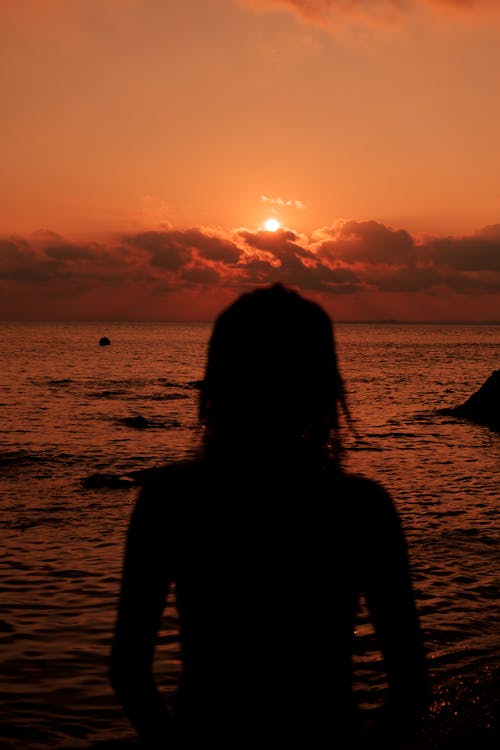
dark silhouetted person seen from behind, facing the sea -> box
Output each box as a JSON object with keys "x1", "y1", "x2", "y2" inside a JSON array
[{"x1": 111, "y1": 285, "x2": 427, "y2": 750}]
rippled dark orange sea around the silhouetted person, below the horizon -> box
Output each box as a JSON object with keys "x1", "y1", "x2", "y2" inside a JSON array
[{"x1": 0, "y1": 322, "x2": 500, "y2": 750}]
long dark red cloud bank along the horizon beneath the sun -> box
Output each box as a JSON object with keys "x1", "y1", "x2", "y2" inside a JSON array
[{"x1": 0, "y1": 220, "x2": 500, "y2": 319}]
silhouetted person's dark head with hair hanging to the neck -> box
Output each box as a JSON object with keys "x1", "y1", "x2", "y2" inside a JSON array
[{"x1": 200, "y1": 284, "x2": 345, "y2": 468}]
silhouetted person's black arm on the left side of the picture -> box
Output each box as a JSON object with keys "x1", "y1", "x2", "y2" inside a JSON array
[{"x1": 110, "y1": 489, "x2": 173, "y2": 748}]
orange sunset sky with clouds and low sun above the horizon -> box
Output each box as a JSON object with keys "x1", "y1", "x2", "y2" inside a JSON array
[{"x1": 0, "y1": 0, "x2": 500, "y2": 320}]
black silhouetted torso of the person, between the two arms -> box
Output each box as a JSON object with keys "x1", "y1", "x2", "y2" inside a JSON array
[{"x1": 145, "y1": 463, "x2": 382, "y2": 744}]
